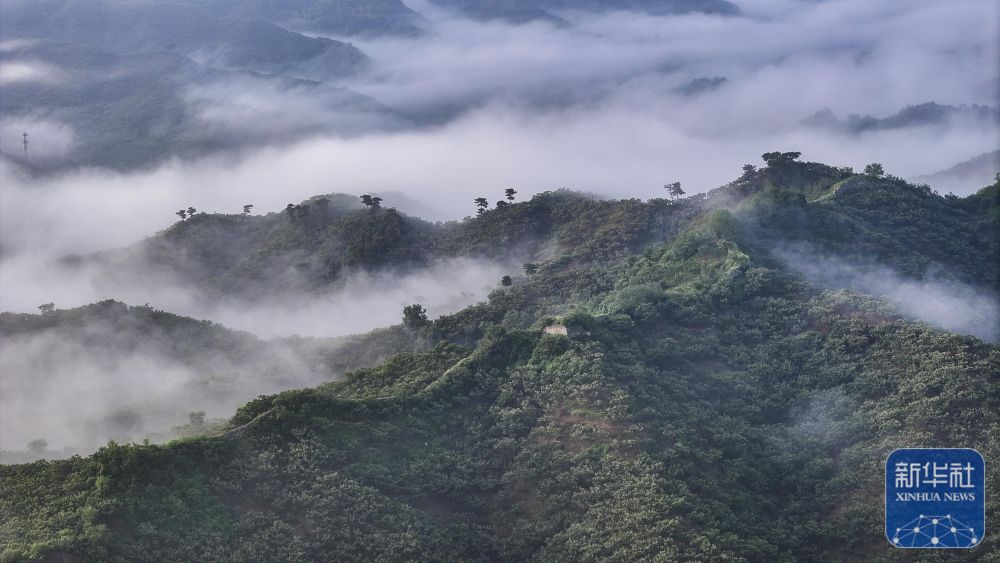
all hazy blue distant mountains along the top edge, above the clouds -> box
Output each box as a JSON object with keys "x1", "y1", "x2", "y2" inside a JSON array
[{"x1": 0, "y1": 0, "x2": 752, "y2": 172}]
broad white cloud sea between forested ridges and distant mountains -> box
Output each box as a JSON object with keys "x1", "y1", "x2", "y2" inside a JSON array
[{"x1": 0, "y1": 0, "x2": 1000, "y2": 320}]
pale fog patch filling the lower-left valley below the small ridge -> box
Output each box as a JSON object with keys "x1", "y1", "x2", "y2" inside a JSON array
[{"x1": 0, "y1": 313, "x2": 332, "y2": 454}]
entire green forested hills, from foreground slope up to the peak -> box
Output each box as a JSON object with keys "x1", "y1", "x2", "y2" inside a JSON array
[{"x1": 0, "y1": 153, "x2": 1000, "y2": 561}]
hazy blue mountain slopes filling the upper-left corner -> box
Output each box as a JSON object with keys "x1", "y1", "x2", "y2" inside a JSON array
[{"x1": 0, "y1": 0, "x2": 405, "y2": 171}]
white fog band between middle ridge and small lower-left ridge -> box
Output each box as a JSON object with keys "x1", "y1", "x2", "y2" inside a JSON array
[{"x1": 0, "y1": 250, "x2": 508, "y2": 337}]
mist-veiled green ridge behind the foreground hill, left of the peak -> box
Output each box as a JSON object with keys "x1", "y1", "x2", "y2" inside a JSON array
[{"x1": 82, "y1": 186, "x2": 694, "y2": 298}]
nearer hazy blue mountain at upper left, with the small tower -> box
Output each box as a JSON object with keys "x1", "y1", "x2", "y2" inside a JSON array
[{"x1": 0, "y1": 41, "x2": 384, "y2": 171}]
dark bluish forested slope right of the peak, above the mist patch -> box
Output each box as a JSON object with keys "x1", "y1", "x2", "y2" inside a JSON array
[{"x1": 731, "y1": 162, "x2": 1000, "y2": 290}]
